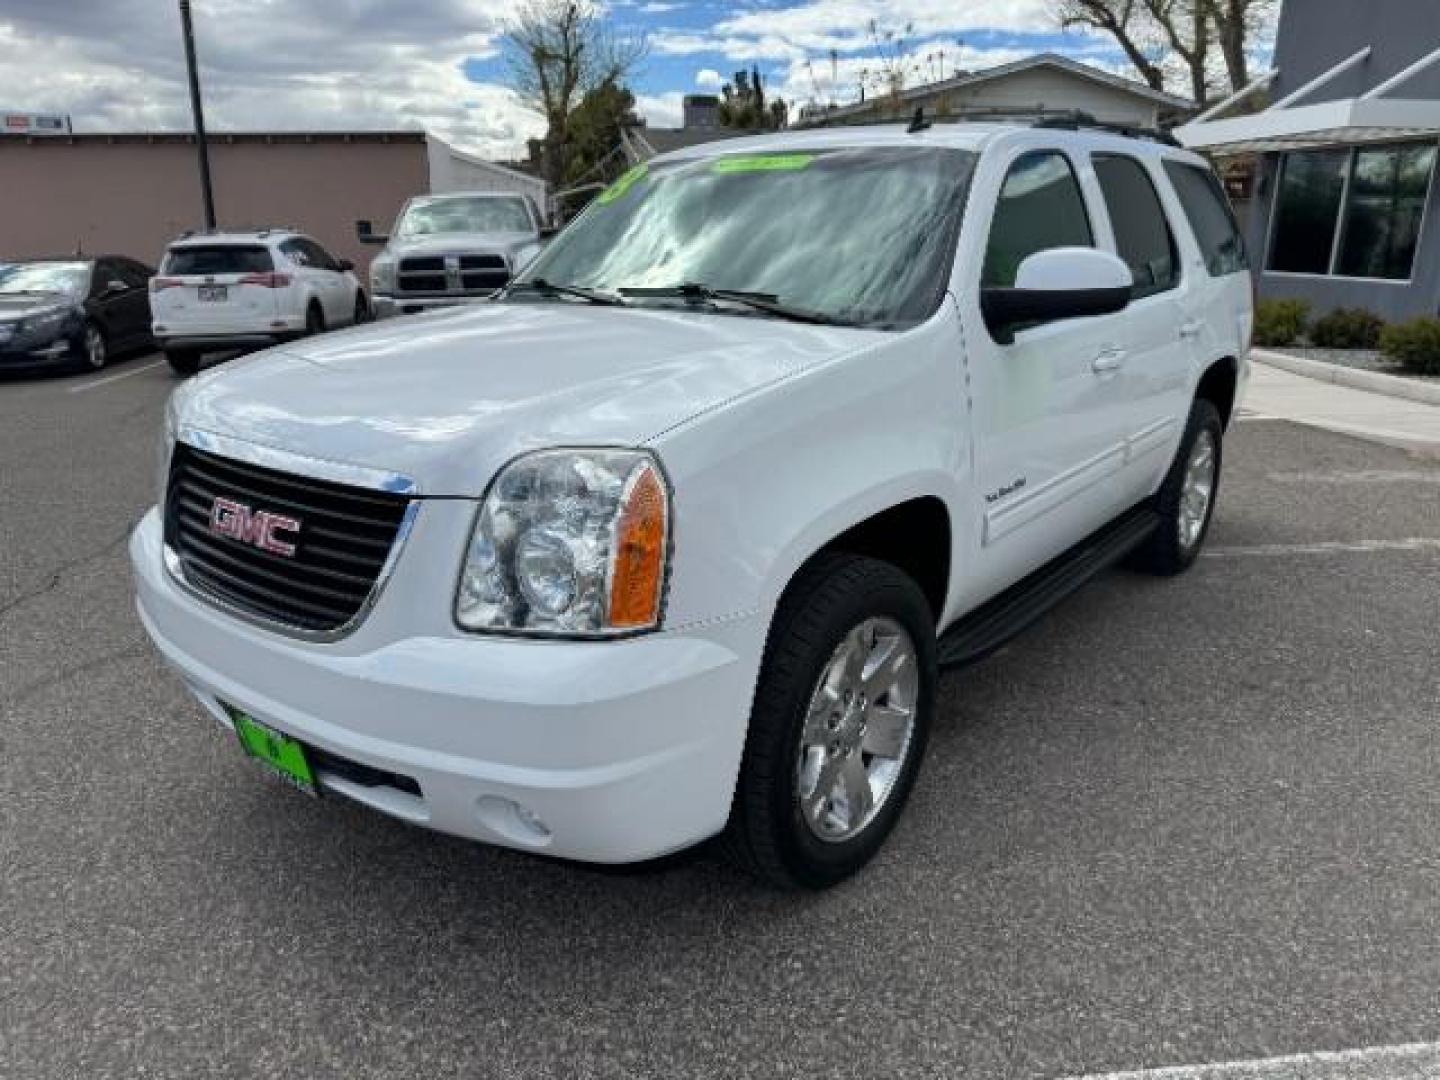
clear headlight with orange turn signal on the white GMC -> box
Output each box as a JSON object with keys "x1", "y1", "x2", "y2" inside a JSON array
[{"x1": 455, "y1": 449, "x2": 670, "y2": 636}]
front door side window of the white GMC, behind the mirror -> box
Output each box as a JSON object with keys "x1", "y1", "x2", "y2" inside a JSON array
[{"x1": 981, "y1": 150, "x2": 1094, "y2": 288}]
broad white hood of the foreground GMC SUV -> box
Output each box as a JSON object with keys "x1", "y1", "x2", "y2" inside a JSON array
[{"x1": 177, "y1": 301, "x2": 883, "y2": 497}]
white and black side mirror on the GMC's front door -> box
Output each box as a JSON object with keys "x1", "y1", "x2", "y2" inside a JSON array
[{"x1": 981, "y1": 248, "x2": 1135, "y2": 346}]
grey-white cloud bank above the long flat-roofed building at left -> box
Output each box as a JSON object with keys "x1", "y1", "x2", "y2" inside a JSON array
[{"x1": 0, "y1": 0, "x2": 543, "y2": 157}]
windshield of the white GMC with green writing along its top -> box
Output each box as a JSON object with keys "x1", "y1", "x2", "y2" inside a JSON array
[{"x1": 523, "y1": 147, "x2": 975, "y2": 328}]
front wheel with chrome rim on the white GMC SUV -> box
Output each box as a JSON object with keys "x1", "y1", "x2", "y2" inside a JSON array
[{"x1": 721, "y1": 554, "x2": 937, "y2": 888}]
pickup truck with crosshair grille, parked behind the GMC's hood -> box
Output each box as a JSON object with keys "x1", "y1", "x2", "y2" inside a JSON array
[{"x1": 356, "y1": 193, "x2": 549, "y2": 318}]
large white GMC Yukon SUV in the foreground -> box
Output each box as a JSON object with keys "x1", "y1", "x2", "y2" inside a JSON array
[{"x1": 131, "y1": 118, "x2": 1251, "y2": 887}]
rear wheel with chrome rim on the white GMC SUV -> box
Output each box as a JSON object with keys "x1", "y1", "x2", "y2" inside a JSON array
[{"x1": 1129, "y1": 397, "x2": 1224, "y2": 577}]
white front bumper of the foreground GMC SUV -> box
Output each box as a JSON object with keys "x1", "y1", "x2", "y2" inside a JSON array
[{"x1": 130, "y1": 510, "x2": 765, "y2": 863}]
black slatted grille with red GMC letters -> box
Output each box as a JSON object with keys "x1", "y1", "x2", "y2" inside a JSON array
[{"x1": 166, "y1": 444, "x2": 409, "y2": 634}]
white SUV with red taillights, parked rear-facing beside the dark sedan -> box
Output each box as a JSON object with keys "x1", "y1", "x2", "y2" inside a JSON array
[{"x1": 150, "y1": 229, "x2": 370, "y2": 374}]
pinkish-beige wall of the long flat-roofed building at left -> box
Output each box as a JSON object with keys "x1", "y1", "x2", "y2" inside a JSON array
[{"x1": 0, "y1": 131, "x2": 429, "y2": 269}]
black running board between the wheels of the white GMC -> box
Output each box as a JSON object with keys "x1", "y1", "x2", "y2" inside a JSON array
[{"x1": 939, "y1": 504, "x2": 1159, "y2": 668}]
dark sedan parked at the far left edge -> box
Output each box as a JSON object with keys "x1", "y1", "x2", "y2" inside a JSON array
[{"x1": 0, "y1": 255, "x2": 154, "y2": 370}]
